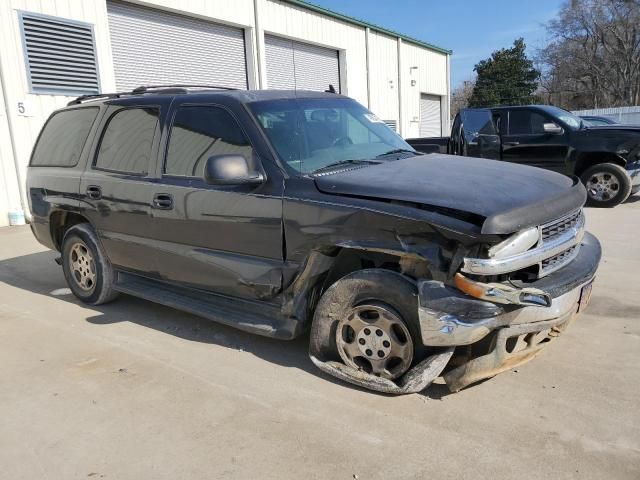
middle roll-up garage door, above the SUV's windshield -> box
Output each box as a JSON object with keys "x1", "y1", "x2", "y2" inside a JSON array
[{"x1": 264, "y1": 35, "x2": 340, "y2": 92}]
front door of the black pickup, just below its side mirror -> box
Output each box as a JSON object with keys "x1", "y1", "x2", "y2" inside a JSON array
[{"x1": 502, "y1": 108, "x2": 569, "y2": 173}]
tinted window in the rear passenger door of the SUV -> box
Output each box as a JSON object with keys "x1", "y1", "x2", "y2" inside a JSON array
[{"x1": 95, "y1": 108, "x2": 158, "y2": 175}]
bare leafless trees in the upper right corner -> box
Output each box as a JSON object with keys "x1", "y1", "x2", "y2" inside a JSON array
[{"x1": 538, "y1": 0, "x2": 640, "y2": 109}]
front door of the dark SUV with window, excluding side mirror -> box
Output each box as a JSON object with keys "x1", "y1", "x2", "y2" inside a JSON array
[{"x1": 152, "y1": 102, "x2": 283, "y2": 300}]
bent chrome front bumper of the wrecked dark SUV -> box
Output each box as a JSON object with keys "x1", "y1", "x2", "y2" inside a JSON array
[{"x1": 418, "y1": 233, "x2": 601, "y2": 347}]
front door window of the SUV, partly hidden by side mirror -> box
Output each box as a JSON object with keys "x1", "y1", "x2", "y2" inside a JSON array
[{"x1": 164, "y1": 106, "x2": 251, "y2": 177}]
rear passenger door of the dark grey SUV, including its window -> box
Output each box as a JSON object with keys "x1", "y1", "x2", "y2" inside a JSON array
[{"x1": 80, "y1": 98, "x2": 167, "y2": 273}]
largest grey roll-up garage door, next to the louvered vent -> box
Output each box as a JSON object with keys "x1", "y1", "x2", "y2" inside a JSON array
[{"x1": 107, "y1": 2, "x2": 247, "y2": 91}]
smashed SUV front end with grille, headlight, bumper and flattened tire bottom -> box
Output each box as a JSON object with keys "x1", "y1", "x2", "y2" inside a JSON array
[{"x1": 310, "y1": 211, "x2": 601, "y2": 394}]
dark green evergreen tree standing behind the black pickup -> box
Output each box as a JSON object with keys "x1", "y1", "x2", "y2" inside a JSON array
[{"x1": 469, "y1": 38, "x2": 540, "y2": 107}]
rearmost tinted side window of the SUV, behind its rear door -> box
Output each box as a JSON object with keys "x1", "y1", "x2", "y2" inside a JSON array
[{"x1": 31, "y1": 107, "x2": 99, "y2": 167}]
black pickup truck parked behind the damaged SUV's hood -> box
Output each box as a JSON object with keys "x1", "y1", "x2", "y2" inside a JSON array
[{"x1": 407, "y1": 105, "x2": 640, "y2": 207}]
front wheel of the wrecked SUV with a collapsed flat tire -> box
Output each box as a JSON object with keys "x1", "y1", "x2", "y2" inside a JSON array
[{"x1": 309, "y1": 269, "x2": 424, "y2": 380}]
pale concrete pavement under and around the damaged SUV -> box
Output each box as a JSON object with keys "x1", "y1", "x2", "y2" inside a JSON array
[{"x1": 0, "y1": 197, "x2": 640, "y2": 480}]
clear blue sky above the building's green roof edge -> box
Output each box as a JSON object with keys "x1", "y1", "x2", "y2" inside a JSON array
[{"x1": 309, "y1": 0, "x2": 563, "y2": 88}]
